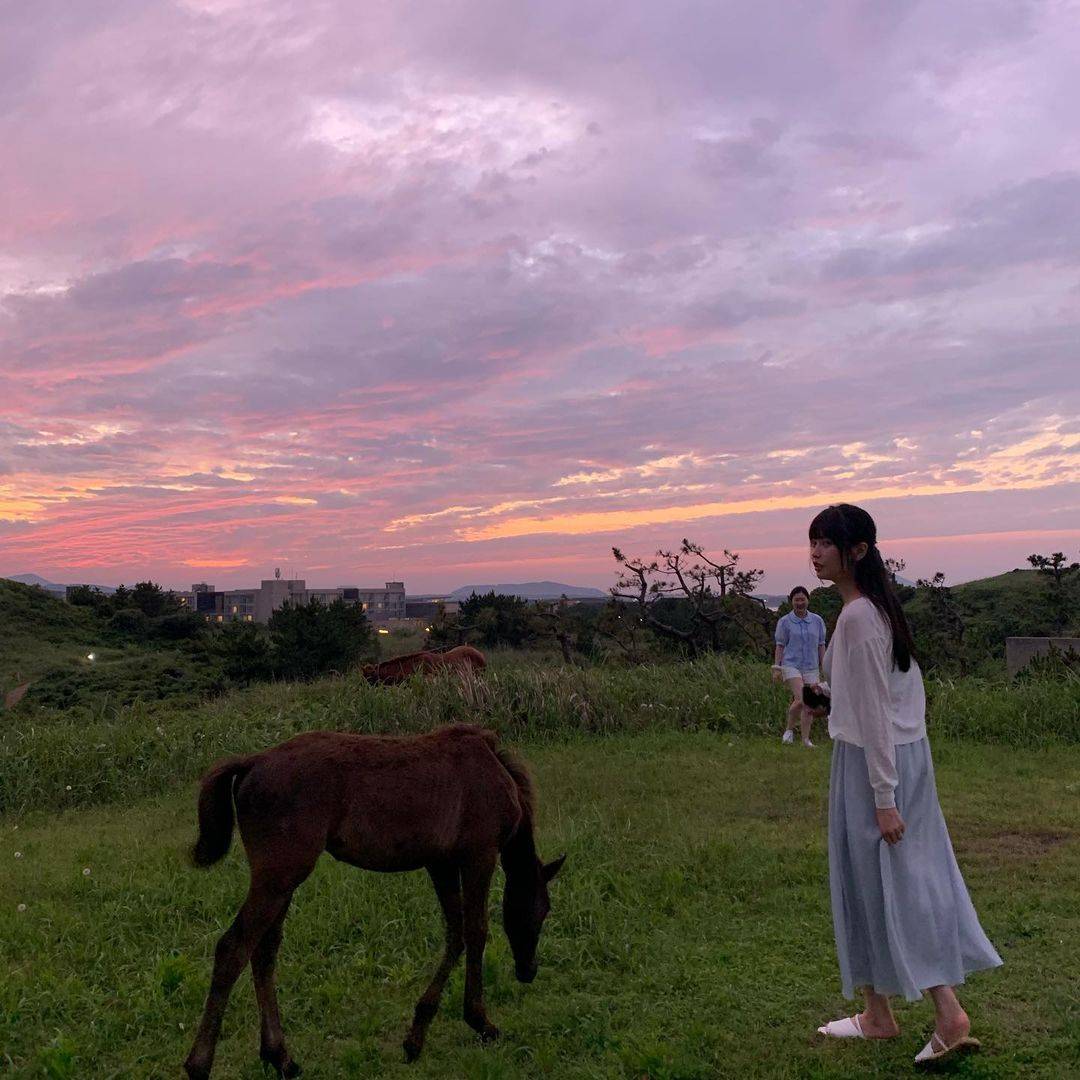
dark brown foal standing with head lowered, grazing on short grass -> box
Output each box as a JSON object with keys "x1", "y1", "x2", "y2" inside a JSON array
[{"x1": 184, "y1": 725, "x2": 566, "y2": 1080}]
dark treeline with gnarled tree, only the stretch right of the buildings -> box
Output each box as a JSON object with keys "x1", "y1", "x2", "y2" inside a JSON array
[{"x1": 431, "y1": 540, "x2": 1080, "y2": 675}]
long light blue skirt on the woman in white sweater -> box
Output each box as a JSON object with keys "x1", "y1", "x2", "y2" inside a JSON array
[{"x1": 828, "y1": 738, "x2": 1002, "y2": 1001}]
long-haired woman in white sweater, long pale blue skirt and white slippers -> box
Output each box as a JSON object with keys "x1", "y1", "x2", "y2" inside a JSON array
[{"x1": 810, "y1": 503, "x2": 1001, "y2": 1064}]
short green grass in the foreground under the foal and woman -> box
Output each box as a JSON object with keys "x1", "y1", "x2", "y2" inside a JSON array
[{"x1": 0, "y1": 729, "x2": 1080, "y2": 1080}]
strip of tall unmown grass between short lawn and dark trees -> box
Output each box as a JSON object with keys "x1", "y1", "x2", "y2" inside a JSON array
[{"x1": 0, "y1": 654, "x2": 1080, "y2": 813}]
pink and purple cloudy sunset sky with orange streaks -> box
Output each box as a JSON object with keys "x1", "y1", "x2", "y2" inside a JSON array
[{"x1": 0, "y1": 0, "x2": 1080, "y2": 593}]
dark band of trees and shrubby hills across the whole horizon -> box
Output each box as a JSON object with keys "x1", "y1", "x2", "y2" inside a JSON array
[{"x1": 10, "y1": 540, "x2": 1080, "y2": 708}]
